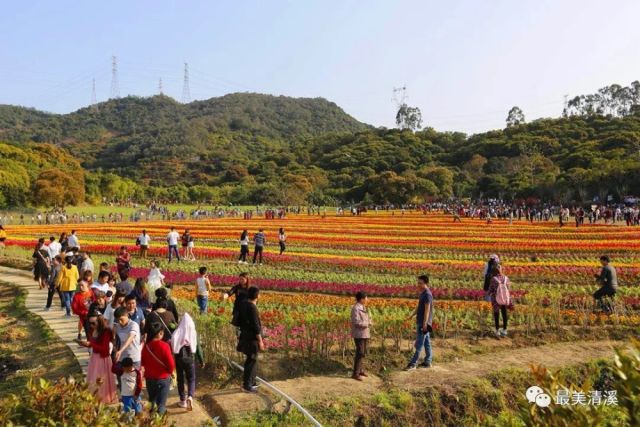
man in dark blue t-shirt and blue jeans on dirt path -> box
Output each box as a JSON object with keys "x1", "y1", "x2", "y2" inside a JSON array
[{"x1": 405, "y1": 274, "x2": 433, "y2": 371}]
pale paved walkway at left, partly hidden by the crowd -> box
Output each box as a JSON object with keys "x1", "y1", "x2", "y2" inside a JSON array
[{"x1": 0, "y1": 266, "x2": 211, "y2": 427}]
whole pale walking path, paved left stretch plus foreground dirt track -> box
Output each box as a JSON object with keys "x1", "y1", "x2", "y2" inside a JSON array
[{"x1": 0, "y1": 266, "x2": 625, "y2": 426}]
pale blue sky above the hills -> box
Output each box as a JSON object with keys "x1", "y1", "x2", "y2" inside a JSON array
[{"x1": 0, "y1": 0, "x2": 640, "y2": 133}]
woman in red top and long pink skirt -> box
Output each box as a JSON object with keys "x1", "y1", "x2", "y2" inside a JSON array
[{"x1": 78, "y1": 312, "x2": 118, "y2": 404}]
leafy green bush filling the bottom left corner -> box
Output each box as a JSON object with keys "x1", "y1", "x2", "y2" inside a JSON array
[{"x1": 0, "y1": 378, "x2": 166, "y2": 427}]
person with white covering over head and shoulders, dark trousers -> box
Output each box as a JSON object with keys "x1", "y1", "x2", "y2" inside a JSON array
[{"x1": 171, "y1": 313, "x2": 204, "y2": 411}]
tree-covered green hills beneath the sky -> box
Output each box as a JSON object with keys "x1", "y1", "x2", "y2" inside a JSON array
[{"x1": 0, "y1": 87, "x2": 640, "y2": 207}]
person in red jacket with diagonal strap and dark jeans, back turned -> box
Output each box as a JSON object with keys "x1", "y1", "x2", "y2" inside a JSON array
[{"x1": 142, "y1": 322, "x2": 176, "y2": 414}]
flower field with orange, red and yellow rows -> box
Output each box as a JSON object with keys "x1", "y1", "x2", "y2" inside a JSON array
[{"x1": 2, "y1": 212, "x2": 640, "y2": 357}]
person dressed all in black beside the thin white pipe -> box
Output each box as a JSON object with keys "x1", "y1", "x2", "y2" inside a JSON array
[{"x1": 237, "y1": 286, "x2": 265, "y2": 393}]
